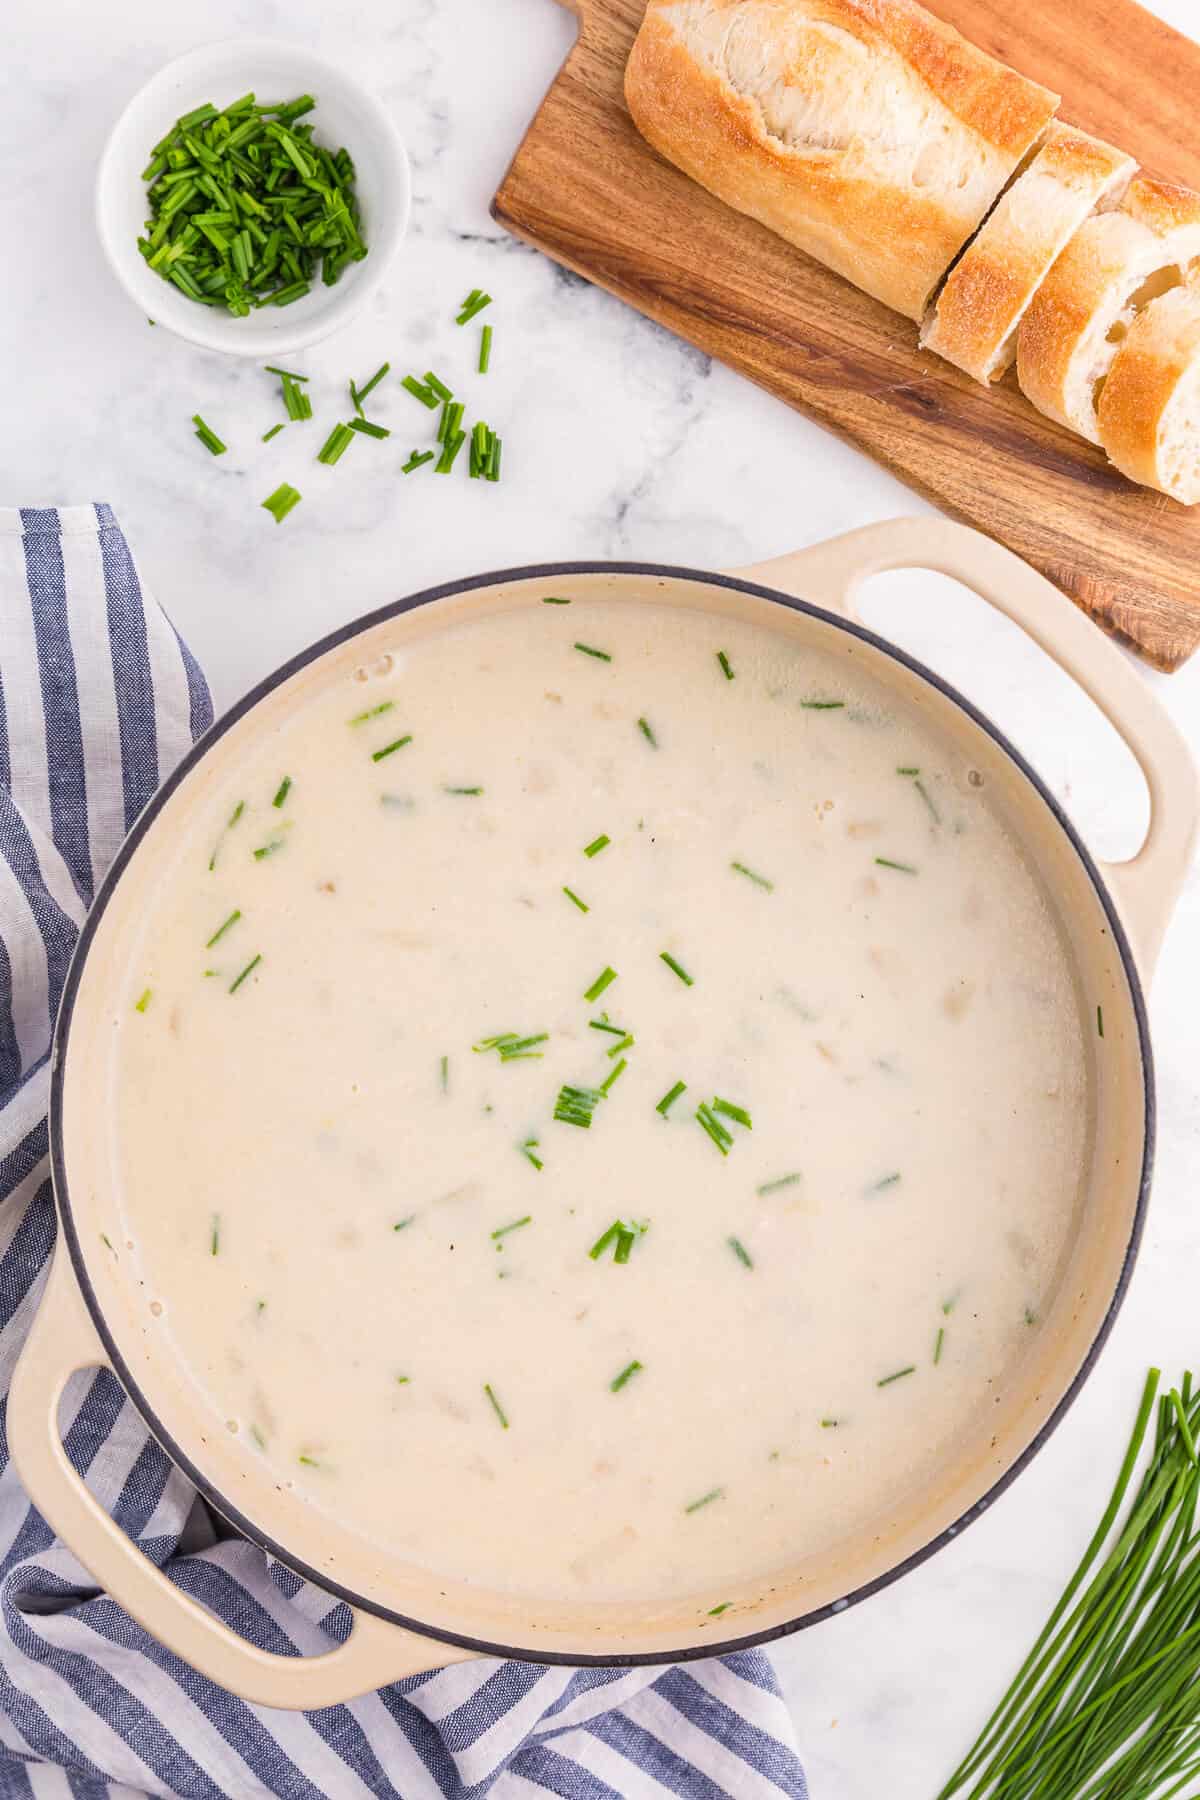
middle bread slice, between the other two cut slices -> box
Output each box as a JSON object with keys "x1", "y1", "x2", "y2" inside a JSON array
[{"x1": 1016, "y1": 175, "x2": 1200, "y2": 445}]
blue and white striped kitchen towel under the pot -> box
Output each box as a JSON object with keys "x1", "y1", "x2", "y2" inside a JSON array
[{"x1": 0, "y1": 506, "x2": 808, "y2": 1800}]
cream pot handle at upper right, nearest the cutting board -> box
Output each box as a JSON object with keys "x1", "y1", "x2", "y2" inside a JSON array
[{"x1": 730, "y1": 518, "x2": 1200, "y2": 974}]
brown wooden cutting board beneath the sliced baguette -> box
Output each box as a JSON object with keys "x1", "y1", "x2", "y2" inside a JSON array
[{"x1": 493, "y1": 0, "x2": 1200, "y2": 670}]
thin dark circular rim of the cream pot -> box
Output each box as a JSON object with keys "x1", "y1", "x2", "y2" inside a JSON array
[{"x1": 49, "y1": 558, "x2": 1157, "y2": 1669}]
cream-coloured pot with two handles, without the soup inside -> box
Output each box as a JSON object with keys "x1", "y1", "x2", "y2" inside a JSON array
[{"x1": 7, "y1": 518, "x2": 1196, "y2": 1708}]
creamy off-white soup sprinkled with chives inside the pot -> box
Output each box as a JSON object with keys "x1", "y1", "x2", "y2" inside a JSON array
[{"x1": 113, "y1": 587, "x2": 1090, "y2": 1611}]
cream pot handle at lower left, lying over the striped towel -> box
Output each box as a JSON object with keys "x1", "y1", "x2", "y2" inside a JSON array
[{"x1": 7, "y1": 1242, "x2": 475, "y2": 1710}]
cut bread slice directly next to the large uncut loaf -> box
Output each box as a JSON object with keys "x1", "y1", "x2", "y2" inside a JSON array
[{"x1": 921, "y1": 124, "x2": 1137, "y2": 385}]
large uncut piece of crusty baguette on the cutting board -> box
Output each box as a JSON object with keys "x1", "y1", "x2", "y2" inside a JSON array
[{"x1": 624, "y1": 0, "x2": 1058, "y2": 319}]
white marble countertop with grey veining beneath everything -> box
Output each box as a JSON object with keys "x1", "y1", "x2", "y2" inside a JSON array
[{"x1": 0, "y1": 0, "x2": 1200, "y2": 1800}]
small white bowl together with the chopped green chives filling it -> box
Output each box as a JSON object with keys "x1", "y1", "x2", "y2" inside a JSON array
[{"x1": 95, "y1": 38, "x2": 410, "y2": 356}]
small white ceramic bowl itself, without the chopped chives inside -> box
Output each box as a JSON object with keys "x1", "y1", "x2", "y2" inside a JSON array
[{"x1": 95, "y1": 38, "x2": 410, "y2": 358}]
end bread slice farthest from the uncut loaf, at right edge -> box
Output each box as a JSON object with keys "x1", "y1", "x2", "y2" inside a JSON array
[{"x1": 1096, "y1": 281, "x2": 1200, "y2": 506}]
